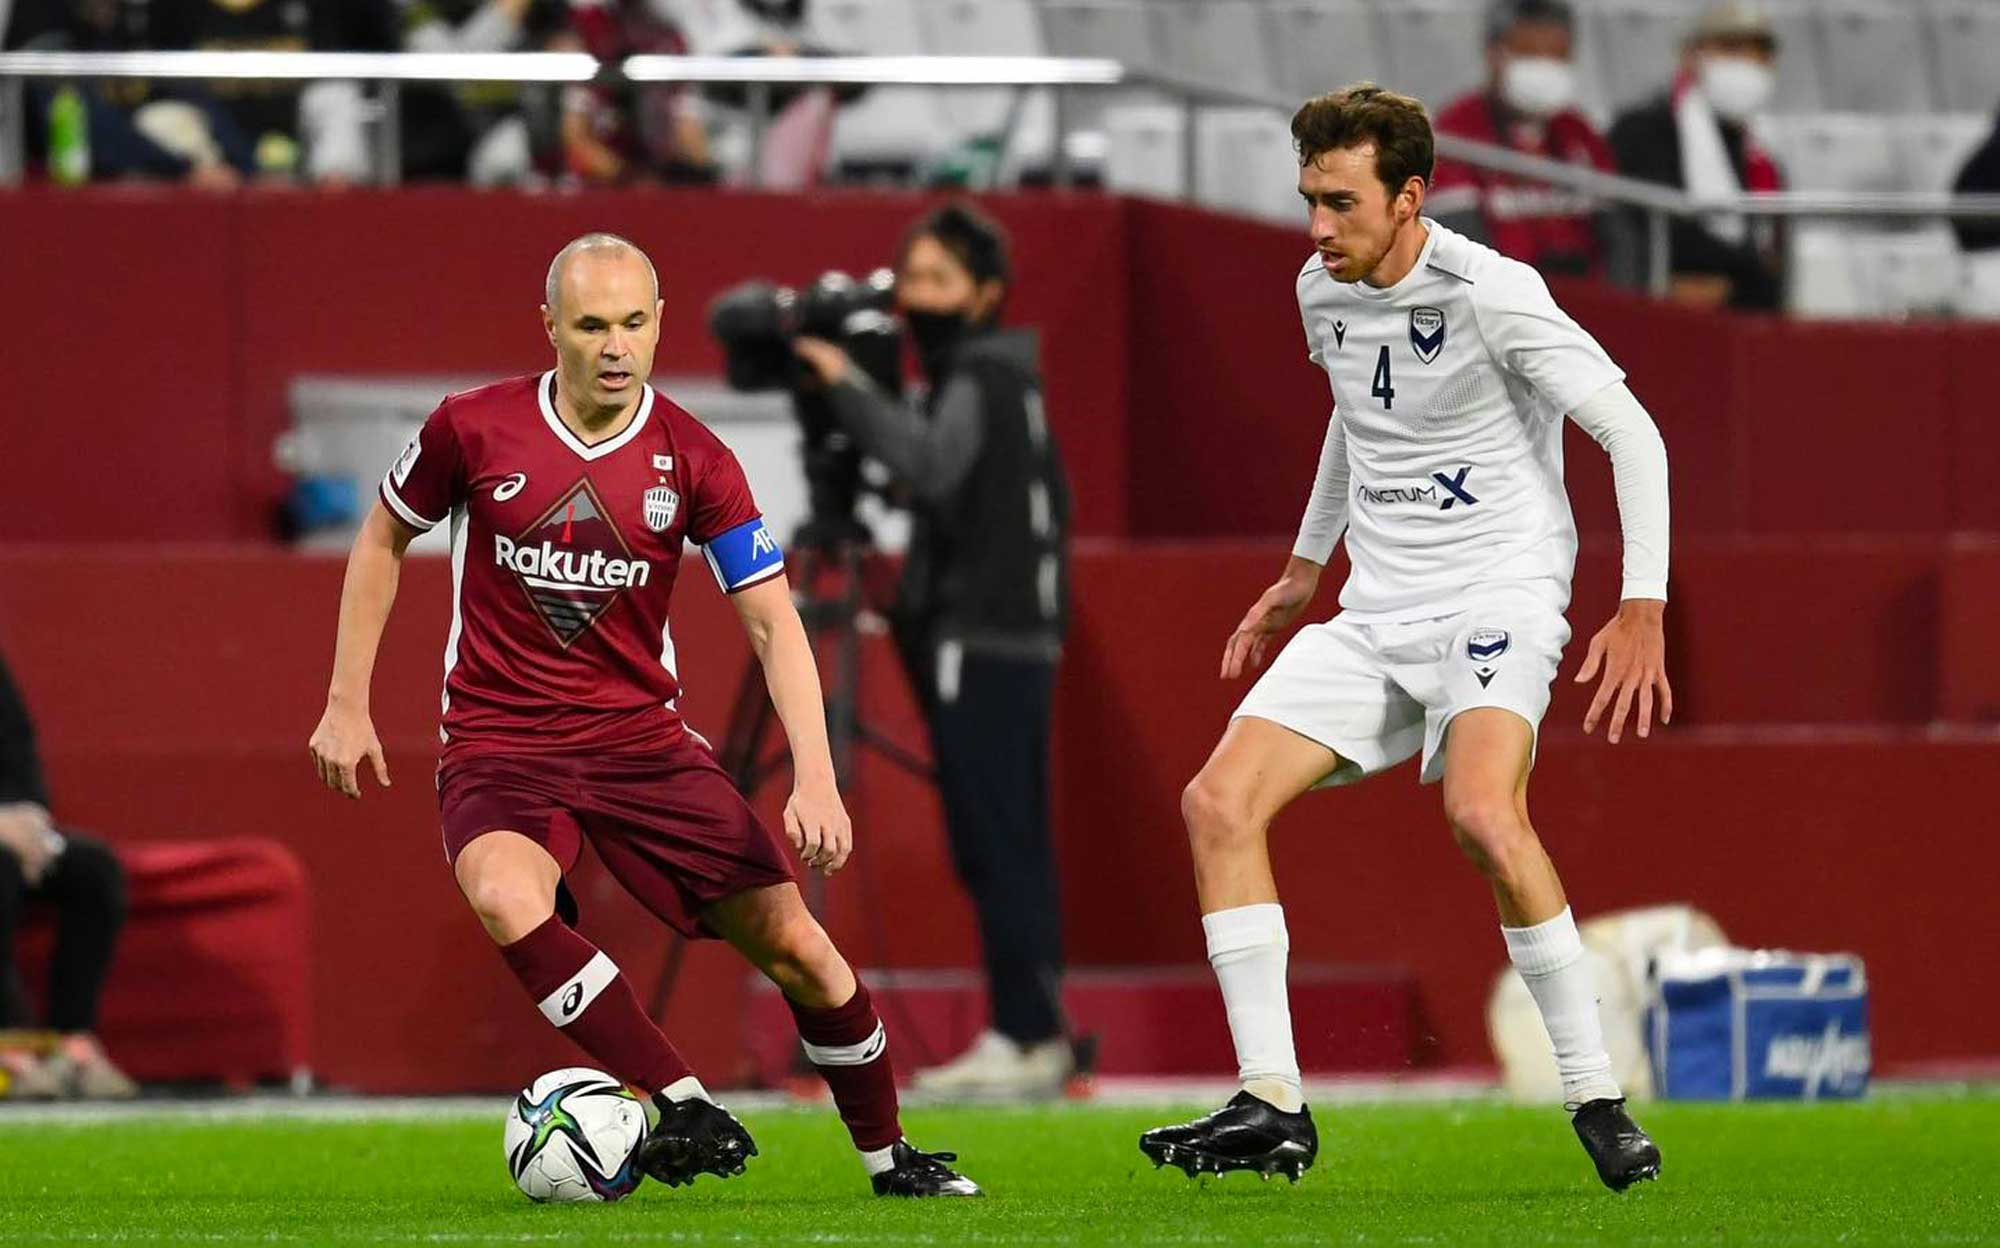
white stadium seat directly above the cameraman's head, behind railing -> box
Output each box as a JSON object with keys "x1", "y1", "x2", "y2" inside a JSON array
[{"x1": 918, "y1": 0, "x2": 1056, "y2": 182}]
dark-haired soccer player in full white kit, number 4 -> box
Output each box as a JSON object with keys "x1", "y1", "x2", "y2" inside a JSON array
[{"x1": 1140, "y1": 84, "x2": 1672, "y2": 1190}]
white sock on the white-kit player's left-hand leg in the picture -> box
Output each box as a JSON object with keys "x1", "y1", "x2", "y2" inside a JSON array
[{"x1": 1202, "y1": 902, "x2": 1304, "y2": 1114}]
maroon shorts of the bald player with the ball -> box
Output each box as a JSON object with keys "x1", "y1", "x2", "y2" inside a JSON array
[{"x1": 438, "y1": 734, "x2": 794, "y2": 936}]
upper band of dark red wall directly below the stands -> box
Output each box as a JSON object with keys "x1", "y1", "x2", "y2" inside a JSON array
[{"x1": 0, "y1": 188, "x2": 2000, "y2": 540}]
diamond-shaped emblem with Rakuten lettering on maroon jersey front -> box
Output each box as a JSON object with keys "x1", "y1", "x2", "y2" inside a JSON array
[{"x1": 494, "y1": 478, "x2": 652, "y2": 650}]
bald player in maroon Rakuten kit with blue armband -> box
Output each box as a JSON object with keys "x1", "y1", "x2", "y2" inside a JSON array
[{"x1": 310, "y1": 234, "x2": 980, "y2": 1196}]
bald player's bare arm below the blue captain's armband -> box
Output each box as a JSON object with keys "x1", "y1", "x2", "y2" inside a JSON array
[{"x1": 730, "y1": 576, "x2": 854, "y2": 876}]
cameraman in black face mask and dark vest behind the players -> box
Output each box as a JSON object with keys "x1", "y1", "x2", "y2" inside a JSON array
[{"x1": 796, "y1": 204, "x2": 1074, "y2": 1096}]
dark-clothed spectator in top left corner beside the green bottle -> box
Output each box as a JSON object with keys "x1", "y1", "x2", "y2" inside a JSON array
[{"x1": 4, "y1": 0, "x2": 254, "y2": 190}]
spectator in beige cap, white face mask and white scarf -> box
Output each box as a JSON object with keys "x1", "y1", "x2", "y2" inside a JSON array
[{"x1": 1612, "y1": 0, "x2": 1784, "y2": 310}]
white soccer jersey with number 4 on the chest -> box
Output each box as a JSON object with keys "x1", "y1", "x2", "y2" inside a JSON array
[{"x1": 1294, "y1": 220, "x2": 1632, "y2": 624}]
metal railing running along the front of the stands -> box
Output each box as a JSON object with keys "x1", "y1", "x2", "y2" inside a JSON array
[{"x1": 0, "y1": 52, "x2": 2000, "y2": 294}]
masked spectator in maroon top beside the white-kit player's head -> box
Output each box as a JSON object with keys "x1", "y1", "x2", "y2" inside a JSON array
[{"x1": 1424, "y1": 0, "x2": 1616, "y2": 276}]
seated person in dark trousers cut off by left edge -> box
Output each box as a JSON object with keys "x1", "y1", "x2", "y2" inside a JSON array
[{"x1": 0, "y1": 648, "x2": 138, "y2": 1098}]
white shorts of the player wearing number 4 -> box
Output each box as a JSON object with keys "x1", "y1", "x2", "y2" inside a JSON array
[{"x1": 1232, "y1": 592, "x2": 1570, "y2": 788}]
